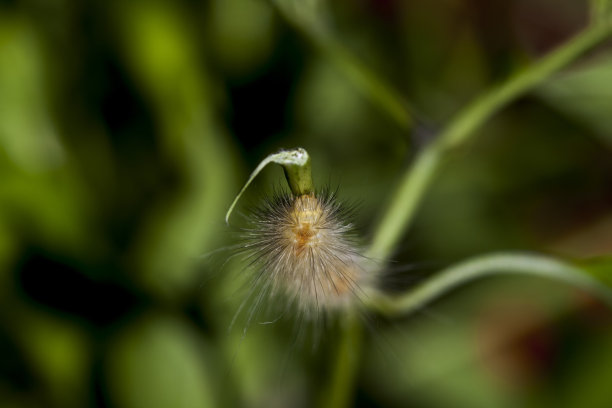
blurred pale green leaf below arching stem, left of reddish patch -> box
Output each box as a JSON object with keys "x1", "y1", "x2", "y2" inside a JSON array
[{"x1": 368, "y1": 320, "x2": 514, "y2": 408}]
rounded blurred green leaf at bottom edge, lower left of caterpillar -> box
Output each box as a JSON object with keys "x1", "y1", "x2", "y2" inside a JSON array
[{"x1": 106, "y1": 316, "x2": 221, "y2": 408}]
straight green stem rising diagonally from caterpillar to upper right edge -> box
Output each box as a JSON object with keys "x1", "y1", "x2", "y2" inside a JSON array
[{"x1": 368, "y1": 21, "x2": 612, "y2": 259}]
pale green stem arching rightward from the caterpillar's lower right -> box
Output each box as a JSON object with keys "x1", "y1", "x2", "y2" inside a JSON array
[{"x1": 371, "y1": 253, "x2": 612, "y2": 316}]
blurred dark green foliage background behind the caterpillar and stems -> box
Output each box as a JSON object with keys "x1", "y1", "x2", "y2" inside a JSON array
[{"x1": 0, "y1": 0, "x2": 612, "y2": 408}]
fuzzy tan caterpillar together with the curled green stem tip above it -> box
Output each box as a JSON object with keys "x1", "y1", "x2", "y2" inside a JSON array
[{"x1": 227, "y1": 149, "x2": 366, "y2": 326}]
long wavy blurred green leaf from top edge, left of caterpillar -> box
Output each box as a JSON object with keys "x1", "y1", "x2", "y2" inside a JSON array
[{"x1": 115, "y1": 2, "x2": 235, "y2": 296}]
